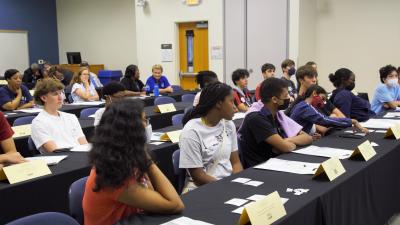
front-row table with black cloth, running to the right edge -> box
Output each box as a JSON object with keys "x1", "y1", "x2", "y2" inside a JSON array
[{"x1": 119, "y1": 127, "x2": 400, "y2": 225}]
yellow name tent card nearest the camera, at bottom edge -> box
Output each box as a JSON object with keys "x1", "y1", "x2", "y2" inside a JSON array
[{"x1": 238, "y1": 191, "x2": 286, "y2": 225}]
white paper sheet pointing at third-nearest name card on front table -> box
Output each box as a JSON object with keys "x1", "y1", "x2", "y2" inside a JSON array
[{"x1": 293, "y1": 145, "x2": 353, "y2": 159}]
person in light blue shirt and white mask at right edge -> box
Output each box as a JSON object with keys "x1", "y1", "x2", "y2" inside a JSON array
[{"x1": 371, "y1": 65, "x2": 400, "y2": 114}]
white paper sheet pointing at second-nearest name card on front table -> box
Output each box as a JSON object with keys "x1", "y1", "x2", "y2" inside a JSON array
[{"x1": 254, "y1": 158, "x2": 320, "y2": 174}]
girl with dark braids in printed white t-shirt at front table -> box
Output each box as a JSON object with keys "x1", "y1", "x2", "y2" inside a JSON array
[{"x1": 179, "y1": 82, "x2": 243, "y2": 191}]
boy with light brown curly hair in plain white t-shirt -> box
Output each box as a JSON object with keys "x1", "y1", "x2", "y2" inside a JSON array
[{"x1": 31, "y1": 78, "x2": 88, "y2": 153}]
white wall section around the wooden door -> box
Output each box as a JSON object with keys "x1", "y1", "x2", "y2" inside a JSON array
[{"x1": 135, "y1": 0, "x2": 223, "y2": 84}]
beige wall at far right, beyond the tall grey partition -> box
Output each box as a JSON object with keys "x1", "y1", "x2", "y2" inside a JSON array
[{"x1": 299, "y1": 0, "x2": 400, "y2": 99}]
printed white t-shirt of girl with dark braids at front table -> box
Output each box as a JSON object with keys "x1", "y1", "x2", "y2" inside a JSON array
[{"x1": 179, "y1": 118, "x2": 238, "y2": 179}]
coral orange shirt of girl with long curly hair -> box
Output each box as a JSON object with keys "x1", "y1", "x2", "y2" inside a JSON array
[{"x1": 82, "y1": 168, "x2": 142, "y2": 225}]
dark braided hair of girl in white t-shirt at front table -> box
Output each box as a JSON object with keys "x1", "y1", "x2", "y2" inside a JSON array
[{"x1": 182, "y1": 82, "x2": 232, "y2": 125}]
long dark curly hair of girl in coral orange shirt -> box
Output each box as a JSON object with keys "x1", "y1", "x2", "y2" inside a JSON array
[{"x1": 89, "y1": 99, "x2": 151, "y2": 192}]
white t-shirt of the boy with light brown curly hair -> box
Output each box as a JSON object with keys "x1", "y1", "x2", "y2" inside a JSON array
[{"x1": 31, "y1": 110, "x2": 85, "y2": 153}]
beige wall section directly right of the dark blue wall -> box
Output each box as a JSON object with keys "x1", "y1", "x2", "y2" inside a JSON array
[{"x1": 56, "y1": 0, "x2": 137, "y2": 72}]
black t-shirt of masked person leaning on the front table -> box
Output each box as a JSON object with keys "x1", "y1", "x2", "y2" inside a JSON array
[{"x1": 238, "y1": 108, "x2": 284, "y2": 168}]
